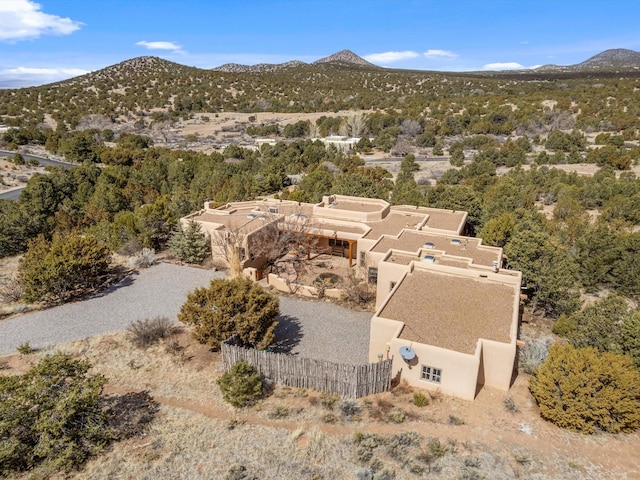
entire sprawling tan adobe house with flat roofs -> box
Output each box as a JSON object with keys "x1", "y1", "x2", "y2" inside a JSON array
[{"x1": 181, "y1": 195, "x2": 521, "y2": 399}]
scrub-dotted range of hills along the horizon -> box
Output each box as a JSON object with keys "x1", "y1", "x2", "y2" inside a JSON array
[{"x1": 0, "y1": 50, "x2": 640, "y2": 129}]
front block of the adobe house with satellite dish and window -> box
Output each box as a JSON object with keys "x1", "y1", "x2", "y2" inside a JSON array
[{"x1": 369, "y1": 255, "x2": 522, "y2": 400}]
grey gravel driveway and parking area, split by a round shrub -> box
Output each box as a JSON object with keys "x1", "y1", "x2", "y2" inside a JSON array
[{"x1": 0, "y1": 263, "x2": 371, "y2": 363}]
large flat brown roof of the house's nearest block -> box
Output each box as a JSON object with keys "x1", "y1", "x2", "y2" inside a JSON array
[{"x1": 379, "y1": 269, "x2": 519, "y2": 354}]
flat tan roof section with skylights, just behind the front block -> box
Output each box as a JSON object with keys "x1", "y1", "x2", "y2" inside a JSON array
[{"x1": 371, "y1": 230, "x2": 502, "y2": 266}]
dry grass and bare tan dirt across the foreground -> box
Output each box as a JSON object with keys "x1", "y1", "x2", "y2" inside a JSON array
[{"x1": 0, "y1": 332, "x2": 640, "y2": 480}]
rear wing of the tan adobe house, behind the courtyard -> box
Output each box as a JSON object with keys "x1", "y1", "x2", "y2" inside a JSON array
[{"x1": 180, "y1": 195, "x2": 467, "y2": 279}]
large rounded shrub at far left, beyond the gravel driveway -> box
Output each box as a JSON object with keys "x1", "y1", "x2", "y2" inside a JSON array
[{"x1": 18, "y1": 234, "x2": 111, "y2": 302}]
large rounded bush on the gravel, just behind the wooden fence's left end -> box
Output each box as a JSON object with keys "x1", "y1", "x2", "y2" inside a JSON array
[{"x1": 178, "y1": 277, "x2": 280, "y2": 349}]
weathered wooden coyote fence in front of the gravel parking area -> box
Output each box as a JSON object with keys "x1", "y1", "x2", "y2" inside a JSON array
[{"x1": 222, "y1": 337, "x2": 391, "y2": 398}]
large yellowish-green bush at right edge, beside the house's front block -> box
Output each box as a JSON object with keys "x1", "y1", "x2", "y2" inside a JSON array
[{"x1": 529, "y1": 345, "x2": 640, "y2": 433}]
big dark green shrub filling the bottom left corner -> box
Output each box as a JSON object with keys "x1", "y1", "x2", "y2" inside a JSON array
[{"x1": 0, "y1": 353, "x2": 113, "y2": 475}]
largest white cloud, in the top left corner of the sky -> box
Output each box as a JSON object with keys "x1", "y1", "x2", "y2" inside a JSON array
[{"x1": 0, "y1": 0, "x2": 82, "y2": 42}]
